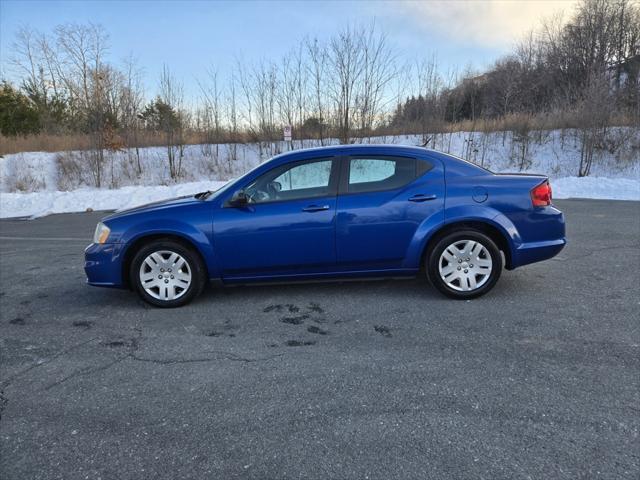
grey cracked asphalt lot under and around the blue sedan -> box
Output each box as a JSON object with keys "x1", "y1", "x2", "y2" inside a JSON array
[{"x1": 0, "y1": 200, "x2": 640, "y2": 480}]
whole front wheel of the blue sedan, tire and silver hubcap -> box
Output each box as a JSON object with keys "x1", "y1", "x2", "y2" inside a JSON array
[{"x1": 129, "y1": 239, "x2": 207, "y2": 308}]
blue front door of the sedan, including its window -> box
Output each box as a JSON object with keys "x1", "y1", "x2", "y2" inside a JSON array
[{"x1": 214, "y1": 157, "x2": 339, "y2": 280}]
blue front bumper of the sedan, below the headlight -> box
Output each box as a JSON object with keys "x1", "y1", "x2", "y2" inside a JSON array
[{"x1": 84, "y1": 243, "x2": 124, "y2": 288}]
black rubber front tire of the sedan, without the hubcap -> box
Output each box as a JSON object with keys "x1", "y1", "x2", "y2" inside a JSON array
[{"x1": 129, "y1": 240, "x2": 206, "y2": 308}]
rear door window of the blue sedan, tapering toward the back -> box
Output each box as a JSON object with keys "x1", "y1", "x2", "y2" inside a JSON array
[{"x1": 343, "y1": 156, "x2": 430, "y2": 193}]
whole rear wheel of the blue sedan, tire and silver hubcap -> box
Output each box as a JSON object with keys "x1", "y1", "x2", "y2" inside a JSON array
[{"x1": 426, "y1": 230, "x2": 502, "y2": 300}]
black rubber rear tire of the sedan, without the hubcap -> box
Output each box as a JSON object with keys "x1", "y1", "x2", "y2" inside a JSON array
[{"x1": 426, "y1": 230, "x2": 502, "y2": 300}]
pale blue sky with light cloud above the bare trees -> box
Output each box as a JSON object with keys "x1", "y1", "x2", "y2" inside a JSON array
[{"x1": 0, "y1": 0, "x2": 575, "y2": 100}]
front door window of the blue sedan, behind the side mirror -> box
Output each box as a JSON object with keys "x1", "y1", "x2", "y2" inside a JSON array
[{"x1": 245, "y1": 158, "x2": 333, "y2": 203}]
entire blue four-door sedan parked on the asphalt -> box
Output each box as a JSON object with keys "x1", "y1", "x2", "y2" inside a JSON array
[{"x1": 85, "y1": 145, "x2": 566, "y2": 307}]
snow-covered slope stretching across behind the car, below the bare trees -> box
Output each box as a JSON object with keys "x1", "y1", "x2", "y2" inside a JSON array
[{"x1": 0, "y1": 128, "x2": 640, "y2": 218}]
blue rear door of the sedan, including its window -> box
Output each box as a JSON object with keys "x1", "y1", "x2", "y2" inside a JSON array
[{"x1": 336, "y1": 155, "x2": 445, "y2": 270}]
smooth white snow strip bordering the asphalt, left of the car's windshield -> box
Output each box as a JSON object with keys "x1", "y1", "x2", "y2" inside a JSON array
[{"x1": 0, "y1": 181, "x2": 225, "y2": 218}]
